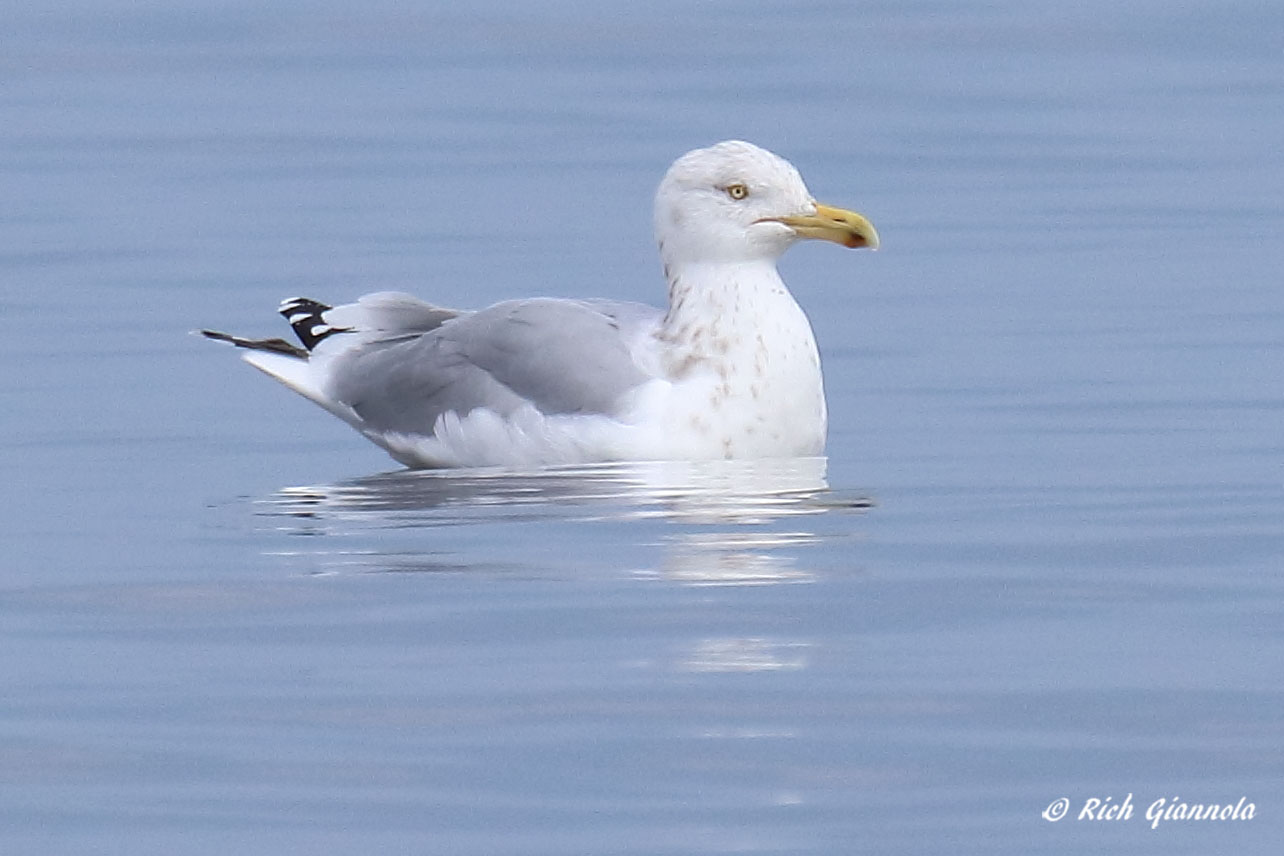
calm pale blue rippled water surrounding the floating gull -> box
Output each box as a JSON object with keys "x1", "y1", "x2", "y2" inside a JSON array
[{"x1": 0, "y1": 0, "x2": 1284, "y2": 856}]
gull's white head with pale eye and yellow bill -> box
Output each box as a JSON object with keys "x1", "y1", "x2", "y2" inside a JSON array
[{"x1": 655, "y1": 140, "x2": 878, "y2": 264}]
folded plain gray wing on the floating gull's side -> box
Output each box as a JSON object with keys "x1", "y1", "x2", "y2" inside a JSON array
[{"x1": 330, "y1": 298, "x2": 661, "y2": 434}]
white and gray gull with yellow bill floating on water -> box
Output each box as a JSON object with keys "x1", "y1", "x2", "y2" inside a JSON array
[{"x1": 202, "y1": 140, "x2": 878, "y2": 467}]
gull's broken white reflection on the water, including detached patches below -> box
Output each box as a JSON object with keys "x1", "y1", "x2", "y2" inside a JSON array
[{"x1": 259, "y1": 458, "x2": 872, "y2": 713}]
